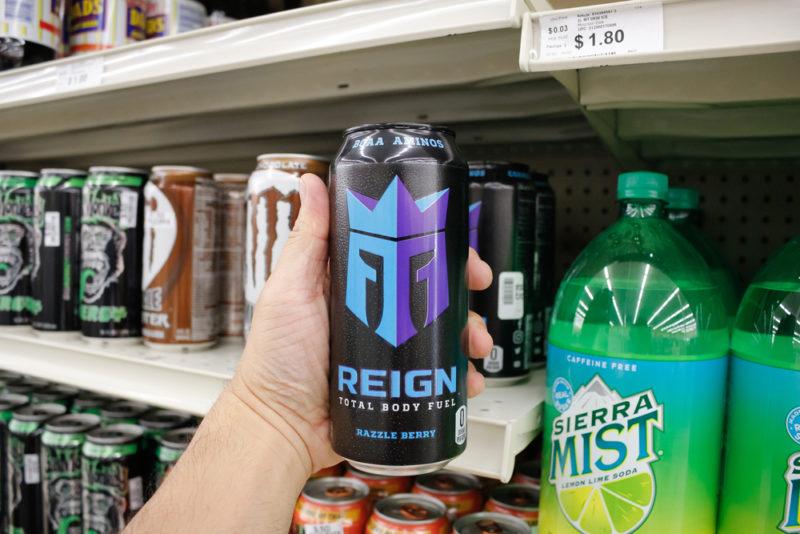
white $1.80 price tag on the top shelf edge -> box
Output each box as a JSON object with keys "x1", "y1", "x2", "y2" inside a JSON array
[{"x1": 538, "y1": 3, "x2": 664, "y2": 60}]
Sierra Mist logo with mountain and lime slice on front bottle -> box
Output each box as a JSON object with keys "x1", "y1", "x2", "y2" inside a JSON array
[{"x1": 549, "y1": 376, "x2": 664, "y2": 534}]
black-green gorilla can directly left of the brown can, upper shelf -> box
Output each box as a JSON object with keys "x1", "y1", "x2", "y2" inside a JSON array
[{"x1": 79, "y1": 167, "x2": 148, "y2": 342}]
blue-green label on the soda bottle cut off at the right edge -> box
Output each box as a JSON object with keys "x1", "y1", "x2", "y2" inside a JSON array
[{"x1": 720, "y1": 357, "x2": 800, "y2": 533}]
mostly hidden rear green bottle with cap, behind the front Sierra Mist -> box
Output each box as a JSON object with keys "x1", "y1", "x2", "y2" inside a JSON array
[{"x1": 667, "y1": 187, "x2": 741, "y2": 322}]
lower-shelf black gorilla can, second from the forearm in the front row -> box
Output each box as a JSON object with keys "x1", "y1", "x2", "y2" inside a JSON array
[{"x1": 81, "y1": 424, "x2": 144, "y2": 534}]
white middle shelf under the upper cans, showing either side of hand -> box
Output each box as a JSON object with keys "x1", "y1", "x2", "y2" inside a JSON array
[{"x1": 0, "y1": 328, "x2": 544, "y2": 480}]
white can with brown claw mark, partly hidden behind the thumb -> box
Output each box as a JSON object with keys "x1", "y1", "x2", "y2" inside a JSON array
[{"x1": 244, "y1": 154, "x2": 330, "y2": 335}]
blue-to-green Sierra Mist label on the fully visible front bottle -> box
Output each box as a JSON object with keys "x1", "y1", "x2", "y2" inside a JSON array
[{"x1": 540, "y1": 345, "x2": 727, "y2": 534}]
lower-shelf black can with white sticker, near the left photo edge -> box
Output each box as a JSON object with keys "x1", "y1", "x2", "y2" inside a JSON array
[{"x1": 6, "y1": 404, "x2": 67, "y2": 534}]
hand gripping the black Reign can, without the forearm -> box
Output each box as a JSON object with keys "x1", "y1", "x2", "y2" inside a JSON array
[{"x1": 230, "y1": 174, "x2": 492, "y2": 480}]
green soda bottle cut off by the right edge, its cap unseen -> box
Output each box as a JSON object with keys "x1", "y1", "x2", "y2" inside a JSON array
[{"x1": 719, "y1": 237, "x2": 800, "y2": 534}]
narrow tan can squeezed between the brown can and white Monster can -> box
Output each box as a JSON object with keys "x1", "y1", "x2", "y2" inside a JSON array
[{"x1": 214, "y1": 174, "x2": 249, "y2": 337}]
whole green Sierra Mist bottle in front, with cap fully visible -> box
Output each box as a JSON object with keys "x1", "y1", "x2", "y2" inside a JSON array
[{"x1": 539, "y1": 172, "x2": 729, "y2": 534}]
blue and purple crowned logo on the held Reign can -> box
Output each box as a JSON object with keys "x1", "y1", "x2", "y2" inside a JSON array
[{"x1": 345, "y1": 176, "x2": 450, "y2": 347}]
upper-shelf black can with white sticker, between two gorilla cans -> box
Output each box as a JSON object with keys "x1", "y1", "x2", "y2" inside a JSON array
[{"x1": 31, "y1": 169, "x2": 86, "y2": 332}]
